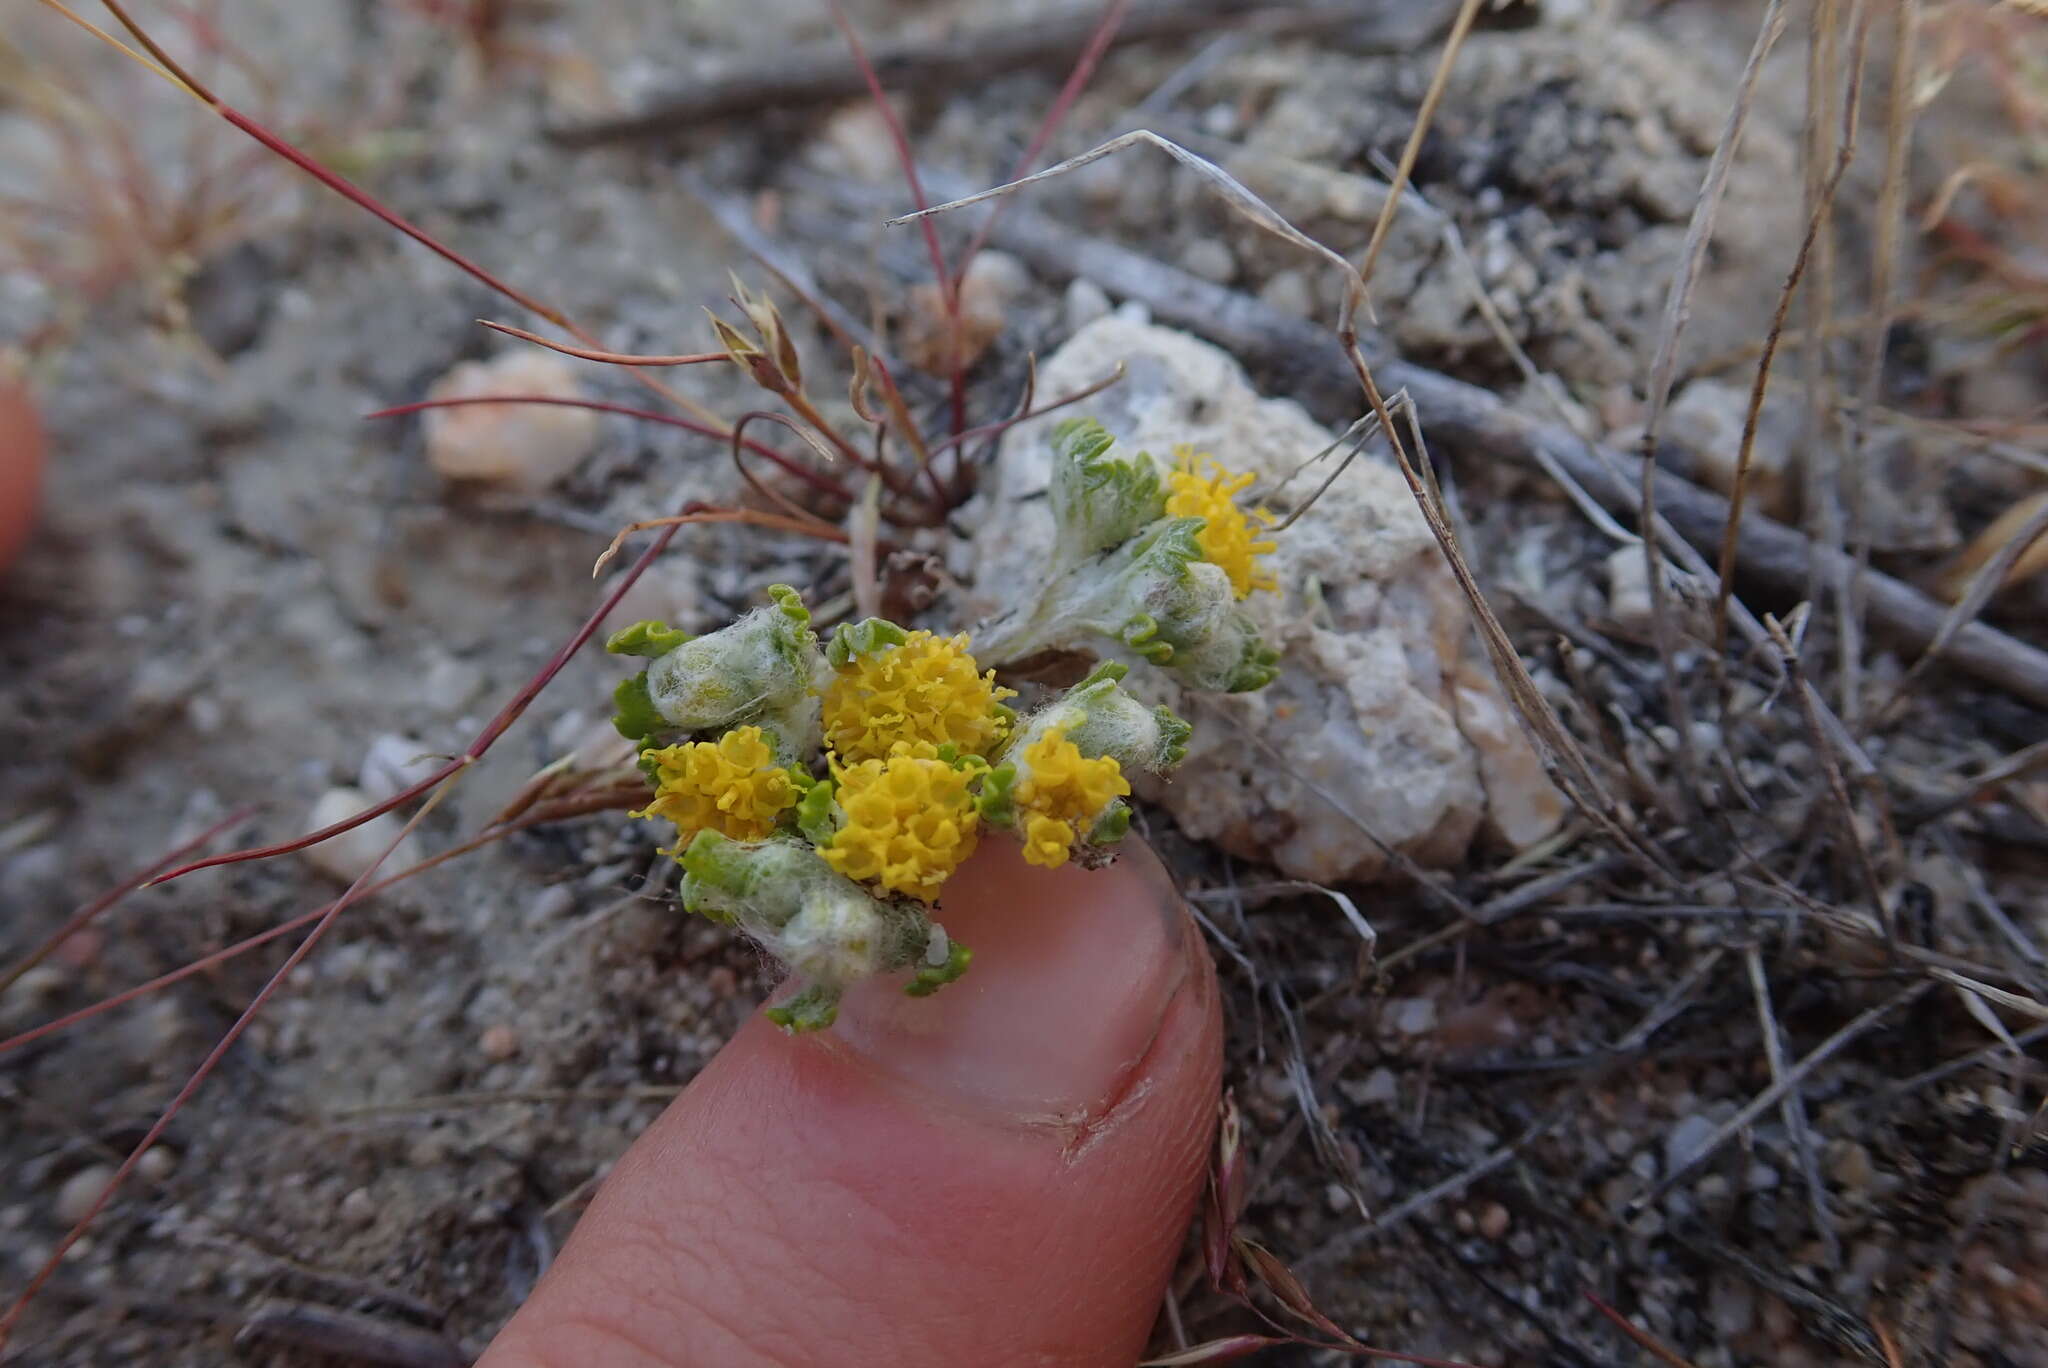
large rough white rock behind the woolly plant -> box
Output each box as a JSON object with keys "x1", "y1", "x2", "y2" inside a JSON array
[{"x1": 963, "y1": 315, "x2": 1548, "y2": 883}]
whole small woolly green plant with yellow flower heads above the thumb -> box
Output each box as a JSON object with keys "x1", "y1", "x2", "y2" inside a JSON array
[{"x1": 606, "y1": 420, "x2": 1276, "y2": 1030}]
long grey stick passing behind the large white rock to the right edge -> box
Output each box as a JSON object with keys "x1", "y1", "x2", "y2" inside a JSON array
[{"x1": 905, "y1": 198, "x2": 2048, "y2": 707}]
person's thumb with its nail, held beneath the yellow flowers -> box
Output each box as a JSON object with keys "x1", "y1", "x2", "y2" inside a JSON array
[{"x1": 479, "y1": 842, "x2": 1223, "y2": 1368}]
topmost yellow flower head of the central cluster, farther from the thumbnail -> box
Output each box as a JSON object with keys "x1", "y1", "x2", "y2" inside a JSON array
[{"x1": 825, "y1": 629, "x2": 1016, "y2": 762}]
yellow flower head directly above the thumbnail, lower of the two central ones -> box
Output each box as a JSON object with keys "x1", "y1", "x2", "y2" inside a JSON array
[{"x1": 819, "y1": 741, "x2": 987, "y2": 903}]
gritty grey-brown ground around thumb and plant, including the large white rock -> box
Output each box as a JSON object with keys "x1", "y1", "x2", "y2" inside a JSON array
[{"x1": 0, "y1": 0, "x2": 2048, "y2": 1368}]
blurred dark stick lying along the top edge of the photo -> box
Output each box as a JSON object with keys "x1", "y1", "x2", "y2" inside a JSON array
[{"x1": 549, "y1": 0, "x2": 1452, "y2": 147}]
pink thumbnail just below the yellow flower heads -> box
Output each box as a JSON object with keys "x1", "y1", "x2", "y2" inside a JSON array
[{"x1": 831, "y1": 838, "x2": 1192, "y2": 1120}]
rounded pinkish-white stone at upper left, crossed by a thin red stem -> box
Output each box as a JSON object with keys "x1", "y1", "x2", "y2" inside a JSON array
[{"x1": 424, "y1": 346, "x2": 598, "y2": 494}]
